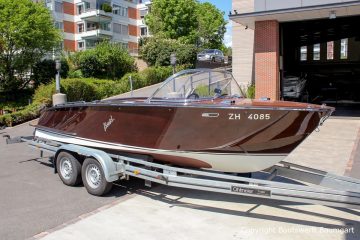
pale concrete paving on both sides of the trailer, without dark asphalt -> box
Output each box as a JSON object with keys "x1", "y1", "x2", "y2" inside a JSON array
[{"x1": 39, "y1": 119, "x2": 360, "y2": 240}]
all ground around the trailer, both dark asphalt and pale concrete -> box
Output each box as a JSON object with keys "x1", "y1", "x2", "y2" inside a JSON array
[{"x1": 0, "y1": 119, "x2": 360, "y2": 240}]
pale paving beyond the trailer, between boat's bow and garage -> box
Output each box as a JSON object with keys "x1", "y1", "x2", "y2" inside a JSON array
[{"x1": 286, "y1": 118, "x2": 360, "y2": 175}]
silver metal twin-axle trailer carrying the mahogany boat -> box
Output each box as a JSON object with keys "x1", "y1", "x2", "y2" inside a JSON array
[{"x1": 6, "y1": 136, "x2": 360, "y2": 209}]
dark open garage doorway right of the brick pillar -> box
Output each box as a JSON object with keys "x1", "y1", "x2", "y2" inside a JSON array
[{"x1": 280, "y1": 15, "x2": 360, "y2": 109}]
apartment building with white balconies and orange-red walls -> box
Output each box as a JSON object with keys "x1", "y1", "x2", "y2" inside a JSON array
[{"x1": 39, "y1": 0, "x2": 150, "y2": 52}]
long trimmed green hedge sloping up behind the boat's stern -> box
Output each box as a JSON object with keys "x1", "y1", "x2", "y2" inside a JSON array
[{"x1": 0, "y1": 66, "x2": 191, "y2": 126}]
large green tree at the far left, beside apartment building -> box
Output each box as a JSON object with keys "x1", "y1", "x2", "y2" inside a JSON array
[{"x1": 0, "y1": 0, "x2": 61, "y2": 91}]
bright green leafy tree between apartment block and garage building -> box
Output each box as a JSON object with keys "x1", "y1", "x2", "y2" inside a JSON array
[{"x1": 145, "y1": 0, "x2": 226, "y2": 48}]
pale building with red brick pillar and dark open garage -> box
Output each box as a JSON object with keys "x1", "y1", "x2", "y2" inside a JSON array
[{"x1": 230, "y1": 0, "x2": 360, "y2": 102}]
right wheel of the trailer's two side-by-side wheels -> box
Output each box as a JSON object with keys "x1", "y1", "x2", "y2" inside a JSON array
[{"x1": 81, "y1": 158, "x2": 112, "y2": 196}]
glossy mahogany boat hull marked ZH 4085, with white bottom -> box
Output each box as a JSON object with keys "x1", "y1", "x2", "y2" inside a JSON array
[{"x1": 37, "y1": 102, "x2": 332, "y2": 172}]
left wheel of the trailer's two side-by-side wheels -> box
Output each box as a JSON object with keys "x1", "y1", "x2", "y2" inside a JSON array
[{"x1": 56, "y1": 152, "x2": 81, "y2": 186}]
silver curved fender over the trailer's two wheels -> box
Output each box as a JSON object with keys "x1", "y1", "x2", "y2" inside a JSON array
[{"x1": 54, "y1": 144, "x2": 119, "y2": 182}]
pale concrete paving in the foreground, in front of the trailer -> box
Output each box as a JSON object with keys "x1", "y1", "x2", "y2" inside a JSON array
[{"x1": 39, "y1": 187, "x2": 360, "y2": 240}]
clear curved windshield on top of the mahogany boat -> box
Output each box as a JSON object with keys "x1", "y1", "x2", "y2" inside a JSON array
[{"x1": 147, "y1": 69, "x2": 244, "y2": 102}]
